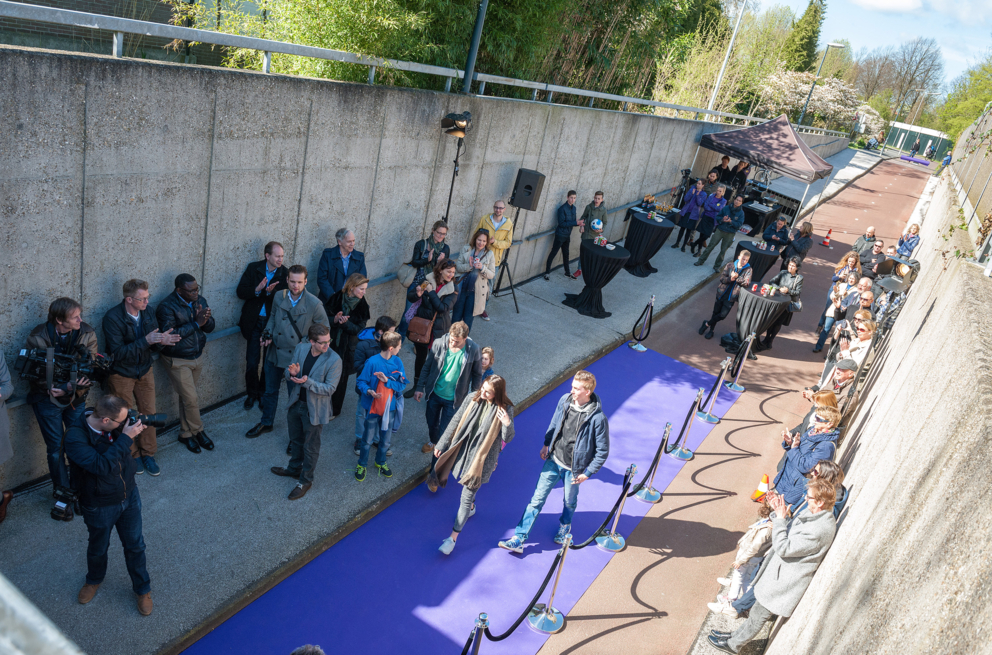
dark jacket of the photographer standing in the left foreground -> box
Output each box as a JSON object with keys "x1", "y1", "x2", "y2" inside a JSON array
[{"x1": 65, "y1": 410, "x2": 136, "y2": 507}]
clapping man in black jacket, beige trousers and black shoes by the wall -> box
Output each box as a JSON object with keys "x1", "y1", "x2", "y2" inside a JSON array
[{"x1": 155, "y1": 273, "x2": 214, "y2": 453}]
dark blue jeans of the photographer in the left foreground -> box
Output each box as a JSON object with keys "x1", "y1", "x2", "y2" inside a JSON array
[{"x1": 82, "y1": 487, "x2": 151, "y2": 596}]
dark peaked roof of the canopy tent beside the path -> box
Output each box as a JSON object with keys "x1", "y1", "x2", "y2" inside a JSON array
[{"x1": 699, "y1": 114, "x2": 834, "y2": 184}]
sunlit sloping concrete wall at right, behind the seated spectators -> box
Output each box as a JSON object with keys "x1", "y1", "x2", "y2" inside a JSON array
[{"x1": 768, "y1": 174, "x2": 992, "y2": 655}]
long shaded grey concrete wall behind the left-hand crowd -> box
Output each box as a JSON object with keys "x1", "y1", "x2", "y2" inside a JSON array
[{"x1": 0, "y1": 47, "x2": 844, "y2": 488}]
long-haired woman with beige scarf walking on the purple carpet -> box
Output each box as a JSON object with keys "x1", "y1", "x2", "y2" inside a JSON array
[{"x1": 427, "y1": 375, "x2": 513, "y2": 555}]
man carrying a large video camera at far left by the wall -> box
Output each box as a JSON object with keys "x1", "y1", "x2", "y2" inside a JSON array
[{"x1": 27, "y1": 298, "x2": 96, "y2": 521}]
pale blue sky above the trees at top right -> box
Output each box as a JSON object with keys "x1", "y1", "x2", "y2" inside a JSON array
[{"x1": 776, "y1": 0, "x2": 992, "y2": 84}]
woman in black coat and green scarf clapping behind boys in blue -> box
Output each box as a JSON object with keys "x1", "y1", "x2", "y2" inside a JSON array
[{"x1": 324, "y1": 273, "x2": 371, "y2": 421}]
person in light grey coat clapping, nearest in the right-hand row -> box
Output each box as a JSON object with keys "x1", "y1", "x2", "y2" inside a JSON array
[{"x1": 708, "y1": 478, "x2": 837, "y2": 653}]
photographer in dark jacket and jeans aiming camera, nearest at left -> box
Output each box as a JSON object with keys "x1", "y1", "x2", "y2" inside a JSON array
[{"x1": 65, "y1": 394, "x2": 152, "y2": 616}]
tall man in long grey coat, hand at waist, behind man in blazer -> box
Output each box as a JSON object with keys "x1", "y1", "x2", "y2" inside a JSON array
[{"x1": 245, "y1": 264, "x2": 330, "y2": 439}]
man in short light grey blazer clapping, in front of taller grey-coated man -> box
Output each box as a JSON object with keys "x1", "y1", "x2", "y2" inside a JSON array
[{"x1": 270, "y1": 323, "x2": 342, "y2": 500}]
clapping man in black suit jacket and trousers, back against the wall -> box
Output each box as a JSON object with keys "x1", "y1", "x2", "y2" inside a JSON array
[{"x1": 237, "y1": 241, "x2": 287, "y2": 409}]
